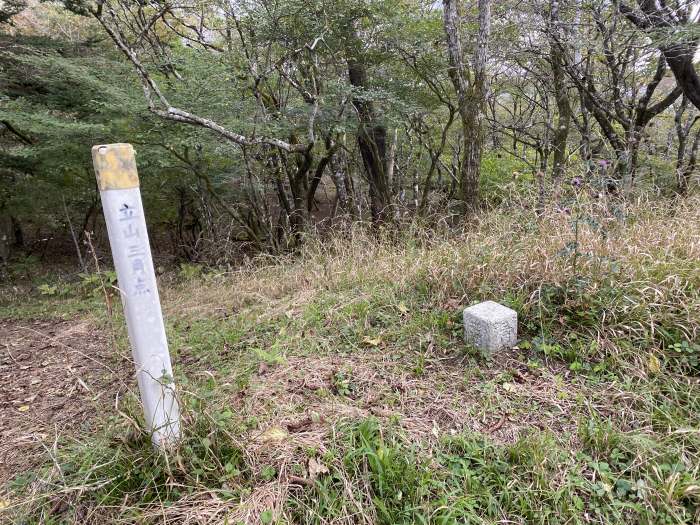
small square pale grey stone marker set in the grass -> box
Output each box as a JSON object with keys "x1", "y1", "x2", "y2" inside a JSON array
[{"x1": 464, "y1": 301, "x2": 518, "y2": 353}]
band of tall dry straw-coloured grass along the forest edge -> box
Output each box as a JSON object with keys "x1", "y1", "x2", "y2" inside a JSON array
[{"x1": 166, "y1": 192, "x2": 700, "y2": 332}]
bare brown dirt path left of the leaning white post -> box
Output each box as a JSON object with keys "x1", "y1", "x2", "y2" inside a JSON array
[{"x1": 0, "y1": 320, "x2": 128, "y2": 488}]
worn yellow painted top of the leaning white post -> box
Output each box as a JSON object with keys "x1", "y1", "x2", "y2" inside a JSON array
[{"x1": 92, "y1": 144, "x2": 139, "y2": 191}]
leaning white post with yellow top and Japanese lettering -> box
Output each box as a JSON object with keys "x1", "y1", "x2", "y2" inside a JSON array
[{"x1": 92, "y1": 144, "x2": 180, "y2": 446}]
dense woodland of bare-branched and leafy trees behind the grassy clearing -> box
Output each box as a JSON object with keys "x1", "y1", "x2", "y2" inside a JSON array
[{"x1": 0, "y1": 0, "x2": 700, "y2": 264}]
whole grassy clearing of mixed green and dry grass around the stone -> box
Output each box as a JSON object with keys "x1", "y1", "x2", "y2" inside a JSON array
[{"x1": 1, "y1": 190, "x2": 700, "y2": 524}]
